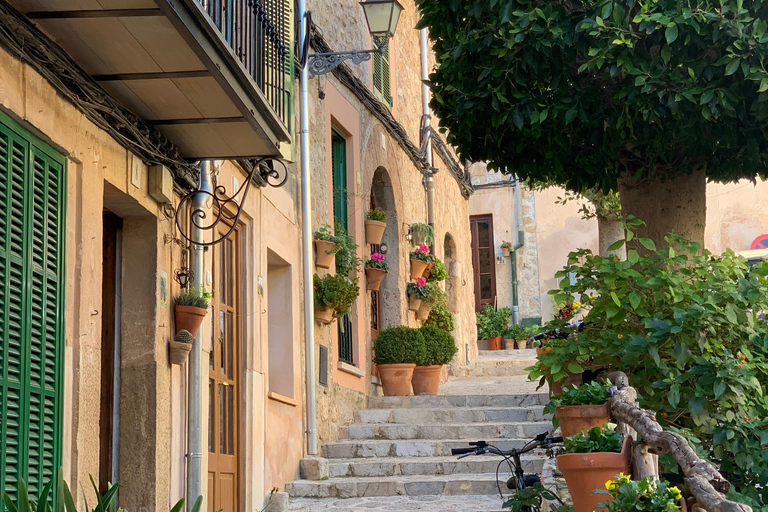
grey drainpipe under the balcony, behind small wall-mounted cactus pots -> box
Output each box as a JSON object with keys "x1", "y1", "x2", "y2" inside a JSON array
[{"x1": 186, "y1": 160, "x2": 213, "y2": 510}]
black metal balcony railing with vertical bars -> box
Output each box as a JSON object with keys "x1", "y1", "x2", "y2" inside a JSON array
[{"x1": 197, "y1": 0, "x2": 293, "y2": 129}]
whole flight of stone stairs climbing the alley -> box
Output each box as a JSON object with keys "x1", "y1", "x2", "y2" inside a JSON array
[{"x1": 286, "y1": 350, "x2": 552, "y2": 512}]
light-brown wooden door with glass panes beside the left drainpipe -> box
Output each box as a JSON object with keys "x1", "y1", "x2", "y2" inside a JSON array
[{"x1": 208, "y1": 226, "x2": 241, "y2": 512}]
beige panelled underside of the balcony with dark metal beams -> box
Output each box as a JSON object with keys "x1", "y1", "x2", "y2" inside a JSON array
[{"x1": 8, "y1": 0, "x2": 290, "y2": 159}]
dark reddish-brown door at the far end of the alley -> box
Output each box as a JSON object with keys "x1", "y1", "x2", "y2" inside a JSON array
[{"x1": 470, "y1": 215, "x2": 496, "y2": 311}]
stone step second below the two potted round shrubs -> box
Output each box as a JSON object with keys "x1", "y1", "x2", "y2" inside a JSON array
[{"x1": 355, "y1": 405, "x2": 546, "y2": 424}]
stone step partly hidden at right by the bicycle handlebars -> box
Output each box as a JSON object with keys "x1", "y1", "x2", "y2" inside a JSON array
[{"x1": 322, "y1": 436, "x2": 552, "y2": 459}]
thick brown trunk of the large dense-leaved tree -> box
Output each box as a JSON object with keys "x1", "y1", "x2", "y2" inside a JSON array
[{"x1": 619, "y1": 168, "x2": 707, "y2": 248}]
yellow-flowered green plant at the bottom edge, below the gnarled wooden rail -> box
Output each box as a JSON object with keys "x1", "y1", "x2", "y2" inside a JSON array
[{"x1": 595, "y1": 475, "x2": 682, "y2": 512}]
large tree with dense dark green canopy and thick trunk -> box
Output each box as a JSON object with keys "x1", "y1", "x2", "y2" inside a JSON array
[{"x1": 416, "y1": 0, "x2": 768, "y2": 245}]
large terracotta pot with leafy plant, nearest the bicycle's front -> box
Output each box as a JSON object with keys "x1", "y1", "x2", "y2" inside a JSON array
[{"x1": 557, "y1": 423, "x2": 630, "y2": 512}]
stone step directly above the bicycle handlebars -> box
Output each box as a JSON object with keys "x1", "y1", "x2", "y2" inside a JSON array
[{"x1": 339, "y1": 421, "x2": 552, "y2": 441}]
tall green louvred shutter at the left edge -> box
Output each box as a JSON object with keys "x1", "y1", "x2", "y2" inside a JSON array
[{"x1": 0, "y1": 112, "x2": 66, "y2": 501}]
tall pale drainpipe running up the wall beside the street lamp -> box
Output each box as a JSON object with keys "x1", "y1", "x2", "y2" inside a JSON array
[{"x1": 297, "y1": 0, "x2": 317, "y2": 455}]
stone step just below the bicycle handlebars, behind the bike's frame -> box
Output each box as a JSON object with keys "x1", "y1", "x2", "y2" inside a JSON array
[{"x1": 328, "y1": 455, "x2": 544, "y2": 478}]
